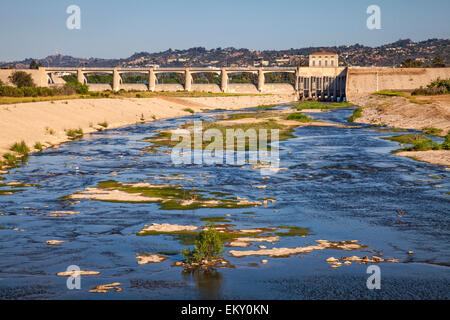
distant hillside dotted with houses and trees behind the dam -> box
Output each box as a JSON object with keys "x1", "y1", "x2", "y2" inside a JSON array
[{"x1": 0, "y1": 39, "x2": 450, "y2": 68}]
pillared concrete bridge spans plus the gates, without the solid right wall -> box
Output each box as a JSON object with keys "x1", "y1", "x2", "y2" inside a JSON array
[{"x1": 40, "y1": 67, "x2": 347, "y2": 101}]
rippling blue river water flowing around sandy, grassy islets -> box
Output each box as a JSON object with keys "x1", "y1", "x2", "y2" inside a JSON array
[{"x1": 0, "y1": 109, "x2": 450, "y2": 299}]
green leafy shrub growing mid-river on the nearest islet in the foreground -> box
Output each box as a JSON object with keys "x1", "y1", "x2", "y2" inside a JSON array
[{"x1": 182, "y1": 223, "x2": 223, "y2": 264}]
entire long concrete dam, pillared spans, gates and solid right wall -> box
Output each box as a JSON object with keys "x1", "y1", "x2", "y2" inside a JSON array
[{"x1": 0, "y1": 67, "x2": 450, "y2": 101}]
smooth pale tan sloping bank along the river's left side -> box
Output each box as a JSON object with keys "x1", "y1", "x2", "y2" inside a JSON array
[{"x1": 0, "y1": 95, "x2": 293, "y2": 154}]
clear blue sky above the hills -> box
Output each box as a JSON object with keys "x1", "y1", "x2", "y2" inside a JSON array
[{"x1": 0, "y1": 0, "x2": 450, "y2": 61}]
